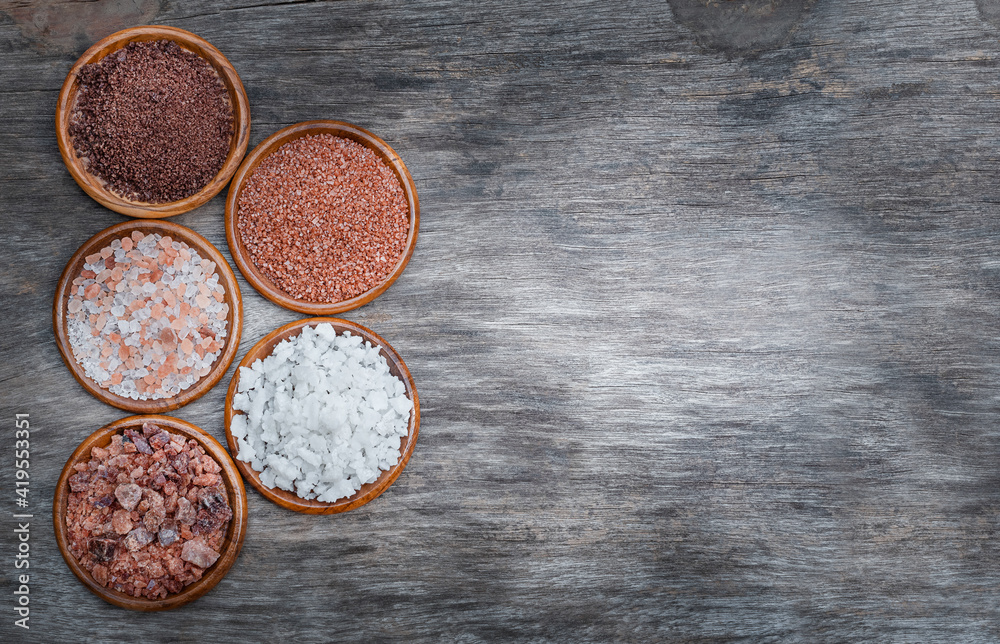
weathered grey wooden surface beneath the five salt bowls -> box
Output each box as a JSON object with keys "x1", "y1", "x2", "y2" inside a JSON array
[{"x1": 0, "y1": 0, "x2": 1000, "y2": 642}]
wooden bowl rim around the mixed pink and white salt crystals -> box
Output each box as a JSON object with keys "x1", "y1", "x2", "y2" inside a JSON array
[{"x1": 52, "y1": 219, "x2": 243, "y2": 414}]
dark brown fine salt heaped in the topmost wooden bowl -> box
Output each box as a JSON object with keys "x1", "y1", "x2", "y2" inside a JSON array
[{"x1": 69, "y1": 40, "x2": 234, "y2": 203}]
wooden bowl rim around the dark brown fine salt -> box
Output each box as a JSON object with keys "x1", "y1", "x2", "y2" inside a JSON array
[{"x1": 56, "y1": 25, "x2": 250, "y2": 218}]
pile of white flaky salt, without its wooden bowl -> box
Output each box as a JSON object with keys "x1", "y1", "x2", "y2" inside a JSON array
[{"x1": 230, "y1": 323, "x2": 413, "y2": 503}]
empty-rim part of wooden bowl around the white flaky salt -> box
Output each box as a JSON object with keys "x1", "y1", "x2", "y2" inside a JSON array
[{"x1": 226, "y1": 318, "x2": 420, "y2": 514}]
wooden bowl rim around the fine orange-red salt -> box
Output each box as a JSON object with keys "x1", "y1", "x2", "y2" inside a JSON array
[{"x1": 226, "y1": 121, "x2": 420, "y2": 315}]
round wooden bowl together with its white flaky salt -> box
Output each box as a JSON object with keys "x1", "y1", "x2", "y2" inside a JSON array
[{"x1": 226, "y1": 318, "x2": 419, "y2": 513}]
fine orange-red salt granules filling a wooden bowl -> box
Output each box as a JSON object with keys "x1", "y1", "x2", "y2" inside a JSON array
[{"x1": 237, "y1": 134, "x2": 409, "y2": 302}]
